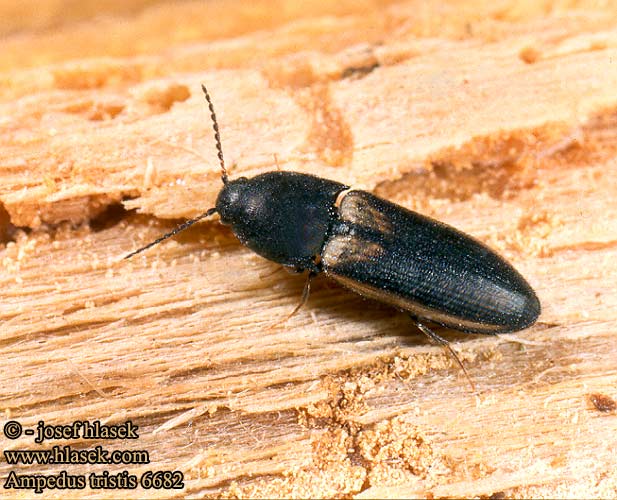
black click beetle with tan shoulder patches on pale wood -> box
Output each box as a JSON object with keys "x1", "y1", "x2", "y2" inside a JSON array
[{"x1": 125, "y1": 85, "x2": 540, "y2": 376}]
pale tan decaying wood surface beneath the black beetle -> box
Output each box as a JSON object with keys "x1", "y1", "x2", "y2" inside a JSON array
[{"x1": 0, "y1": 1, "x2": 617, "y2": 498}]
